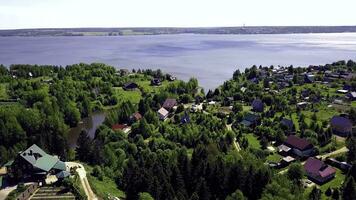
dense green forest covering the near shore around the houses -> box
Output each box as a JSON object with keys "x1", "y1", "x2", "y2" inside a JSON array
[{"x1": 0, "y1": 60, "x2": 356, "y2": 200}]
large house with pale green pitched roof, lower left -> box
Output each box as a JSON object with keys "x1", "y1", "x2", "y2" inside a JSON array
[{"x1": 11, "y1": 144, "x2": 66, "y2": 179}]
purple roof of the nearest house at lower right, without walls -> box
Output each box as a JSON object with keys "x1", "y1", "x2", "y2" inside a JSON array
[{"x1": 304, "y1": 157, "x2": 336, "y2": 177}]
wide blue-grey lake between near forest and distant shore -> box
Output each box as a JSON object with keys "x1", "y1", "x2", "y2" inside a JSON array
[{"x1": 0, "y1": 33, "x2": 356, "y2": 89}]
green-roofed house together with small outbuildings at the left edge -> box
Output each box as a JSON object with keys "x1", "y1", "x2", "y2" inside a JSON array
[{"x1": 0, "y1": 144, "x2": 70, "y2": 188}]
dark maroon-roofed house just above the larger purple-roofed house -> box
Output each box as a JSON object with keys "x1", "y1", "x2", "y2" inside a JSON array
[{"x1": 278, "y1": 135, "x2": 314, "y2": 157}]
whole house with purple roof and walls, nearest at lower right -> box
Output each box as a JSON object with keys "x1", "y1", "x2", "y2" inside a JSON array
[{"x1": 304, "y1": 157, "x2": 336, "y2": 184}]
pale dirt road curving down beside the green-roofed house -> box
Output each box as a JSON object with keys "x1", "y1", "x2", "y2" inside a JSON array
[{"x1": 66, "y1": 162, "x2": 98, "y2": 200}]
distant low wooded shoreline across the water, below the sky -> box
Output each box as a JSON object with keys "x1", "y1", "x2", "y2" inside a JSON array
[{"x1": 0, "y1": 26, "x2": 356, "y2": 37}]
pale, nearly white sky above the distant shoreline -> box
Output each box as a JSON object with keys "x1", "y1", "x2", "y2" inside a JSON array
[{"x1": 0, "y1": 0, "x2": 356, "y2": 29}]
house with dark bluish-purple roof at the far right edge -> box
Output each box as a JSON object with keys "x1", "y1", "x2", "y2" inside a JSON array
[{"x1": 330, "y1": 116, "x2": 352, "y2": 137}]
